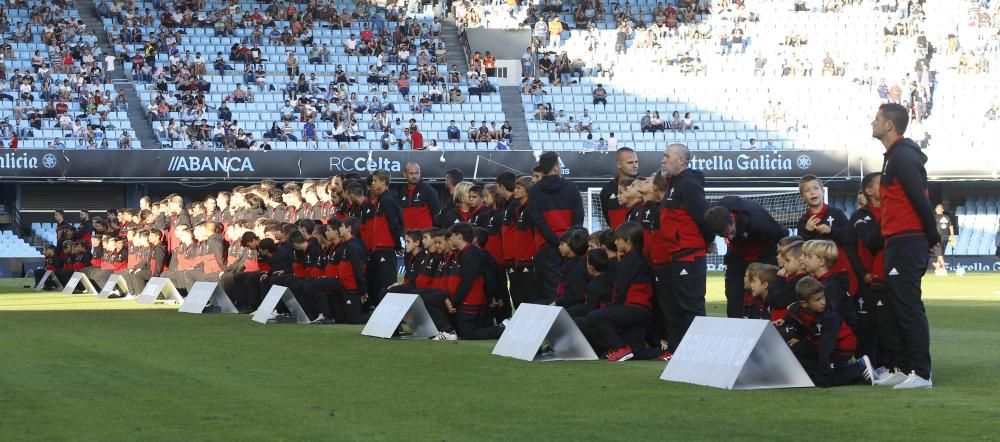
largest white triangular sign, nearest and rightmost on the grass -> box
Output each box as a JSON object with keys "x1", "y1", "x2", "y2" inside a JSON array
[{"x1": 660, "y1": 316, "x2": 813, "y2": 390}]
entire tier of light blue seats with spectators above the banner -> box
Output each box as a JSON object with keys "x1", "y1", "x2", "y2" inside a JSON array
[{"x1": 0, "y1": 0, "x2": 1000, "y2": 150}]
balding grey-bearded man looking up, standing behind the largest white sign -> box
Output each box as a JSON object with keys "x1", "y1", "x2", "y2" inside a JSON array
[{"x1": 654, "y1": 144, "x2": 715, "y2": 352}]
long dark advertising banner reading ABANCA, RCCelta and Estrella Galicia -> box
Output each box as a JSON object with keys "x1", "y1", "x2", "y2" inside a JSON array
[{"x1": 0, "y1": 150, "x2": 948, "y2": 182}]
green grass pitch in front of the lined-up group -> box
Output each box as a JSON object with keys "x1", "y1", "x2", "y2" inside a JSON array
[{"x1": 0, "y1": 274, "x2": 1000, "y2": 441}]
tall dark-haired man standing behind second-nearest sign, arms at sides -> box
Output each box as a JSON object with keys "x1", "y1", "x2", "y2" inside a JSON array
[{"x1": 527, "y1": 152, "x2": 583, "y2": 304}]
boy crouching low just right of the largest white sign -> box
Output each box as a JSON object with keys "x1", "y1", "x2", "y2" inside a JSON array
[{"x1": 774, "y1": 277, "x2": 875, "y2": 387}]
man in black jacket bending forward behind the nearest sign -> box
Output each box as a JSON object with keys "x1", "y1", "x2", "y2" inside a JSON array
[{"x1": 705, "y1": 196, "x2": 788, "y2": 318}]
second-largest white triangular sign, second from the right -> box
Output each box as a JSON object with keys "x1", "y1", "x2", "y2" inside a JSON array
[{"x1": 493, "y1": 304, "x2": 597, "y2": 361}]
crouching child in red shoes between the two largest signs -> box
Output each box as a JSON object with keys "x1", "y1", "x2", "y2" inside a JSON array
[{"x1": 584, "y1": 221, "x2": 663, "y2": 361}]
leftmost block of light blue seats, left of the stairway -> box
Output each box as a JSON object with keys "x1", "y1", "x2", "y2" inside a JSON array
[{"x1": 0, "y1": 0, "x2": 135, "y2": 149}]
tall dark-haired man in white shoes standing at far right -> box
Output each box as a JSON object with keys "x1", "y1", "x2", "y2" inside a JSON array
[{"x1": 872, "y1": 103, "x2": 941, "y2": 388}]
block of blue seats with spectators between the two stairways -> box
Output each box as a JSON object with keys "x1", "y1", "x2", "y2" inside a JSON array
[{"x1": 98, "y1": 1, "x2": 504, "y2": 149}]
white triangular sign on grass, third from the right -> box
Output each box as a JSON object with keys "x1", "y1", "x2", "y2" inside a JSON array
[{"x1": 361, "y1": 293, "x2": 438, "y2": 339}]
